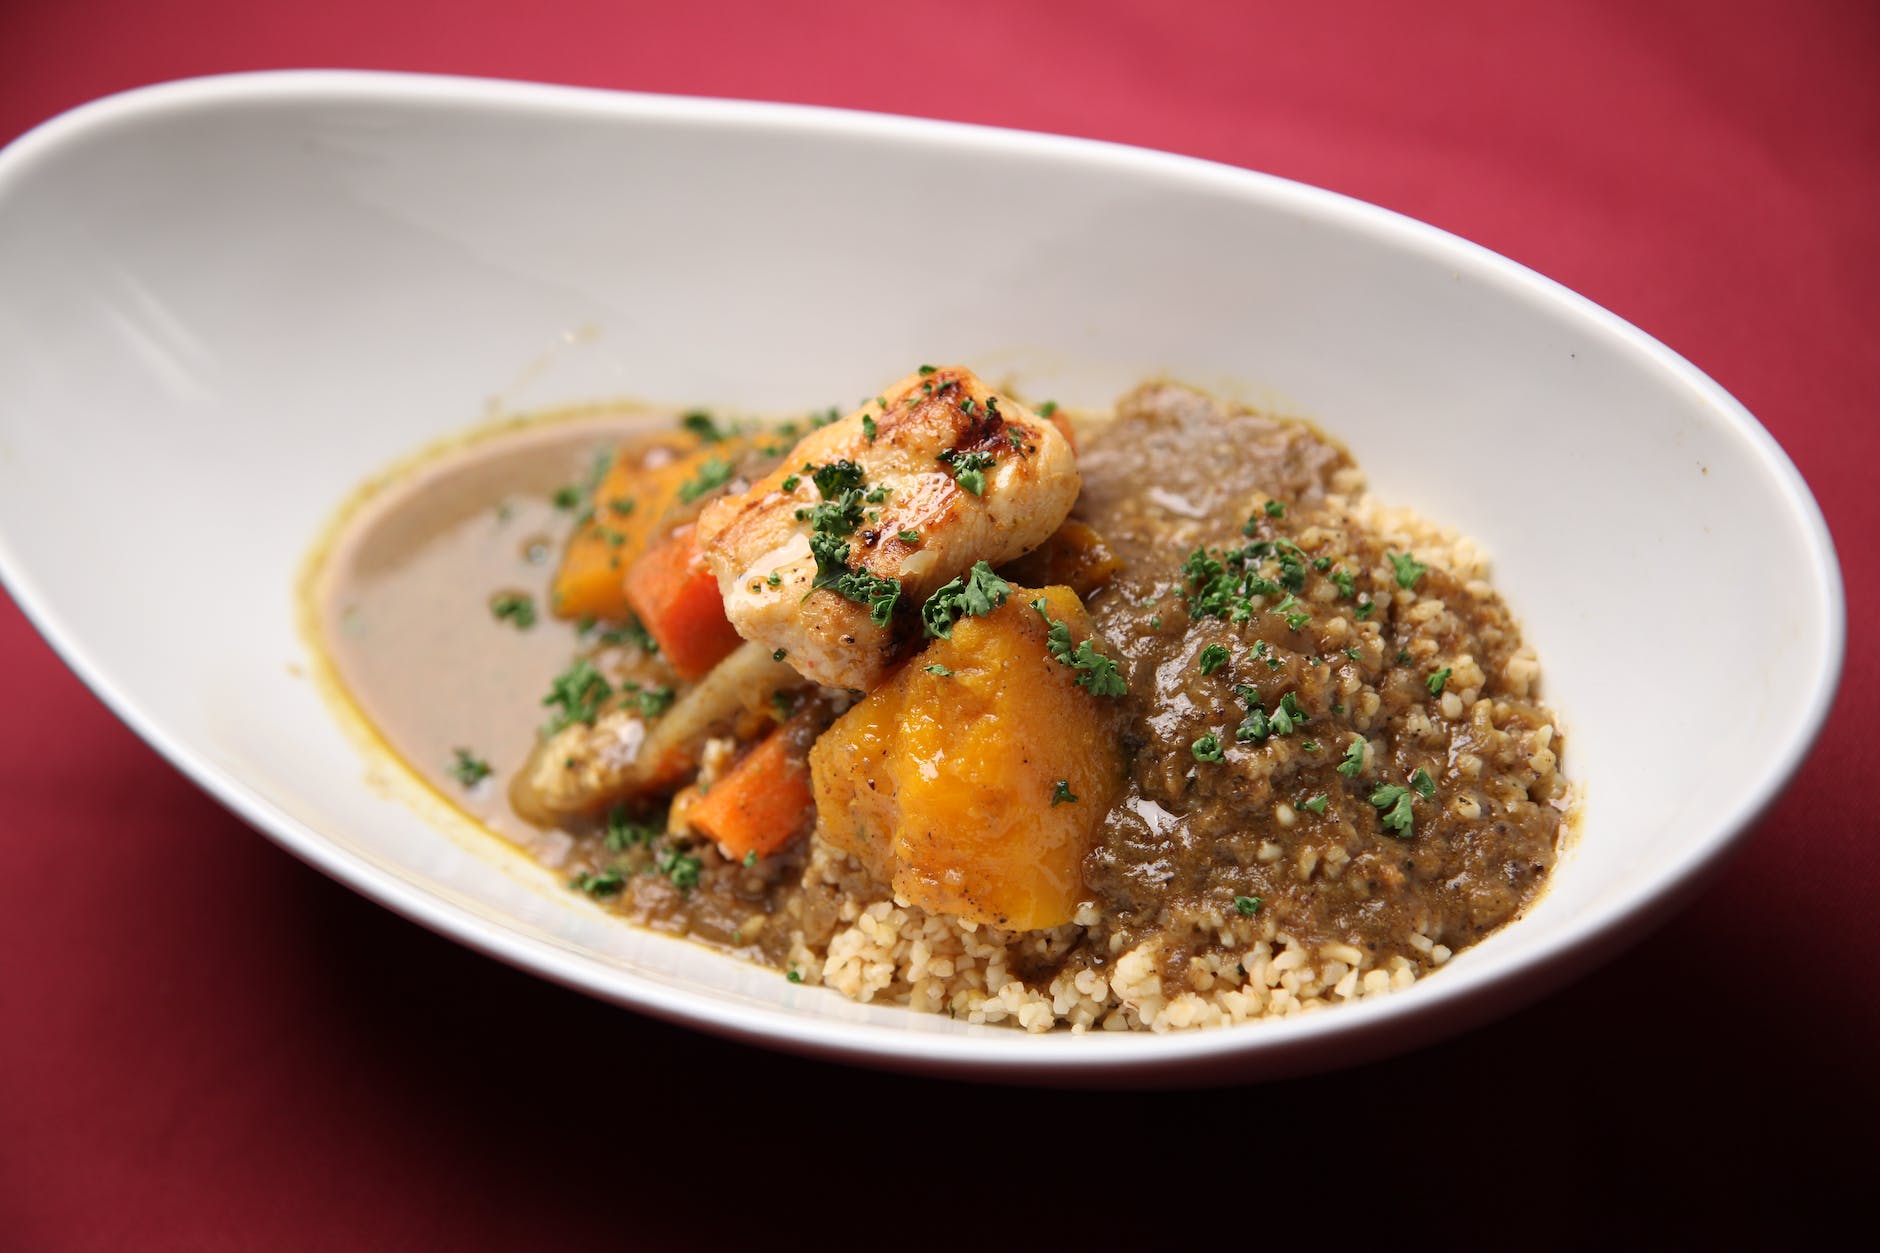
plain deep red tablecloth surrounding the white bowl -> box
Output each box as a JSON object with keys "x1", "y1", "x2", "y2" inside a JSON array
[{"x1": 0, "y1": 0, "x2": 1880, "y2": 1249}]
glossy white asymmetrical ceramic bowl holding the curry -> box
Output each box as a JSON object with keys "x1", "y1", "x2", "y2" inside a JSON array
[{"x1": 0, "y1": 73, "x2": 1844, "y2": 1082}]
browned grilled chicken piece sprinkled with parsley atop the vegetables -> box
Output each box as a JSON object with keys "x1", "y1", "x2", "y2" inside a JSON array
[{"x1": 697, "y1": 367, "x2": 1081, "y2": 690}]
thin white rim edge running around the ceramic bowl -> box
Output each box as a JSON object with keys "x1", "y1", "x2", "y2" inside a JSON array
[{"x1": 0, "y1": 70, "x2": 1846, "y2": 1084}]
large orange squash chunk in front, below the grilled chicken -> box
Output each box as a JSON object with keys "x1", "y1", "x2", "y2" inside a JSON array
[{"x1": 810, "y1": 587, "x2": 1122, "y2": 931}]
